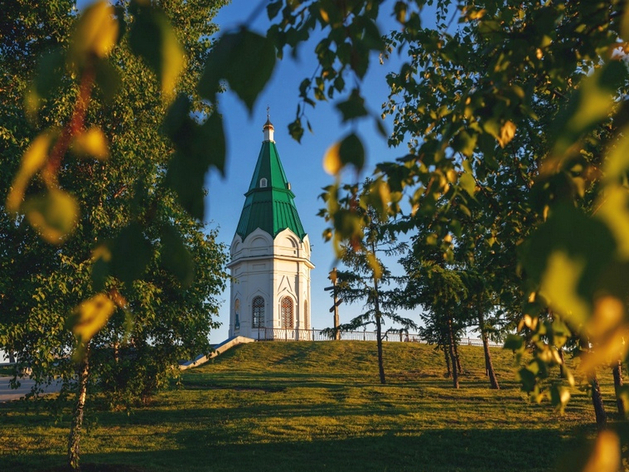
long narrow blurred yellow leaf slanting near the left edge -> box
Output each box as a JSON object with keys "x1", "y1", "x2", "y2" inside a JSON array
[{"x1": 6, "y1": 131, "x2": 55, "y2": 214}]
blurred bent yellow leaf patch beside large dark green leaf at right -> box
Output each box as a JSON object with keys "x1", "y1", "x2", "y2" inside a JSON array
[{"x1": 539, "y1": 251, "x2": 590, "y2": 326}]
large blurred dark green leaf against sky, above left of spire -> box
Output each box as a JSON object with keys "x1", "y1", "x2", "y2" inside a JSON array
[{"x1": 199, "y1": 29, "x2": 276, "y2": 113}]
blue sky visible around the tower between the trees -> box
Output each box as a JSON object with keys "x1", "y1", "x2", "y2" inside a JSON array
[{"x1": 206, "y1": 0, "x2": 418, "y2": 342}]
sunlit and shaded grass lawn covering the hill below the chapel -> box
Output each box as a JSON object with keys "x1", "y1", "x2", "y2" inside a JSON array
[{"x1": 0, "y1": 342, "x2": 614, "y2": 472}]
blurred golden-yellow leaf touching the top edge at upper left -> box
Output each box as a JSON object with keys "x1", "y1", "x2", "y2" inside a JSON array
[{"x1": 72, "y1": 0, "x2": 118, "y2": 63}]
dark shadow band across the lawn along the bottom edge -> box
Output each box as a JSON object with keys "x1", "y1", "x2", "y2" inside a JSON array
[{"x1": 9, "y1": 429, "x2": 580, "y2": 472}]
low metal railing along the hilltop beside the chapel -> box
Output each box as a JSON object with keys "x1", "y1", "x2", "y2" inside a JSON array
[{"x1": 252, "y1": 328, "x2": 502, "y2": 347}]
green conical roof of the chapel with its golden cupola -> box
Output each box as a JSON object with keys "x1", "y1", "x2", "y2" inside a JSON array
[{"x1": 236, "y1": 127, "x2": 306, "y2": 241}]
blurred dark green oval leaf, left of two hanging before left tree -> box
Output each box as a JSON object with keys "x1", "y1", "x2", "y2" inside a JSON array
[{"x1": 111, "y1": 223, "x2": 153, "y2": 286}]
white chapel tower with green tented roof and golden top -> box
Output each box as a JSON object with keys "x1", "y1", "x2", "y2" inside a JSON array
[{"x1": 228, "y1": 118, "x2": 314, "y2": 340}]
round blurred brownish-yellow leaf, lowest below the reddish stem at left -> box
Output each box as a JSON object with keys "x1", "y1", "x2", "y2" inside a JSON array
[{"x1": 23, "y1": 189, "x2": 79, "y2": 244}]
